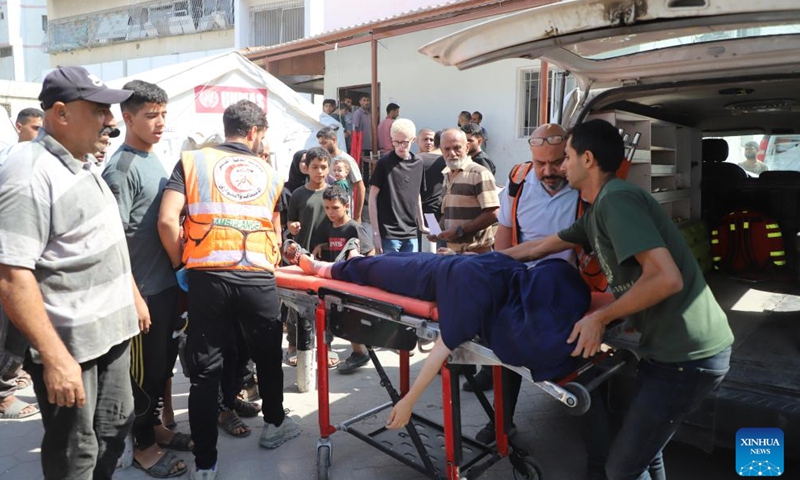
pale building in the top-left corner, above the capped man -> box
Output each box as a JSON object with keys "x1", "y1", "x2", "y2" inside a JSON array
[{"x1": 0, "y1": 0, "x2": 49, "y2": 82}]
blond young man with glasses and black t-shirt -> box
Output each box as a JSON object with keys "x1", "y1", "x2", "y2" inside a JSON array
[{"x1": 369, "y1": 118, "x2": 424, "y2": 254}]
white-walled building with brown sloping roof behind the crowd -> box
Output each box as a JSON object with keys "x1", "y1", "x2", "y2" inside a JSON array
[{"x1": 247, "y1": 0, "x2": 570, "y2": 183}]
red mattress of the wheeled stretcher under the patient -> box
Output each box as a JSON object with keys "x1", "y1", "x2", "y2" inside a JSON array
[{"x1": 275, "y1": 266, "x2": 614, "y2": 321}]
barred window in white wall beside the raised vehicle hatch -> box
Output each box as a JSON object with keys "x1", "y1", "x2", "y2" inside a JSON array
[{"x1": 517, "y1": 68, "x2": 575, "y2": 138}]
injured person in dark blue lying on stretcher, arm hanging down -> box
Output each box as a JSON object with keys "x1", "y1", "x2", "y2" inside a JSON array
[{"x1": 284, "y1": 245, "x2": 591, "y2": 428}]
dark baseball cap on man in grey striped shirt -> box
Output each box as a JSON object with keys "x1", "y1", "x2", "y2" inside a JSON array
[{"x1": 39, "y1": 67, "x2": 133, "y2": 110}]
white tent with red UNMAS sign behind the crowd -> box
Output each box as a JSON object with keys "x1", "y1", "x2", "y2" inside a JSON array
[{"x1": 106, "y1": 52, "x2": 344, "y2": 178}]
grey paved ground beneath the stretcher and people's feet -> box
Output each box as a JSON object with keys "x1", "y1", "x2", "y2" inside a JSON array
[{"x1": 0, "y1": 340, "x2": 798, "y2": 480}]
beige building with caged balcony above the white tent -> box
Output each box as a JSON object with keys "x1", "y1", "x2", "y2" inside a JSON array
[{"x1": 47, "y1": 0, "x2": 309, "y2": 80}]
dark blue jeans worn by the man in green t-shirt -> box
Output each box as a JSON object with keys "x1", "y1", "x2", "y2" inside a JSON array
[{"x1": 606, "y1": 347, "x2": 731, "y2": 480}]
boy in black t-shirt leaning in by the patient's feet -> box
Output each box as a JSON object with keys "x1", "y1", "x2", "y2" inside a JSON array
[{"x1": 313, "y1": 185, "x2": 375, "y2": 374}]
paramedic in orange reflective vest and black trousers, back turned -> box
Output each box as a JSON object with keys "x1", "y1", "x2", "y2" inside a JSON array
[{"x1": 158, "y1": 100, "x2": 300, "y2": 479}]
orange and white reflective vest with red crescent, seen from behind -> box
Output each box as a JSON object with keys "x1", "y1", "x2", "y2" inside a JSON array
[{"x1": 181, "y1": 148, "x2": 283, "y2": 271}]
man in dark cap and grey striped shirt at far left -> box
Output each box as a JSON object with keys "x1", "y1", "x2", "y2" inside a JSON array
[{"x1": 0, "y1": 67, "x2": 150, "y2": 480}]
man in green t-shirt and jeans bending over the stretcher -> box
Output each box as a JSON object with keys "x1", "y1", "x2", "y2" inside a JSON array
[{"x1": 504, "y1": 120, "x2": 733, "y2": 480}]
